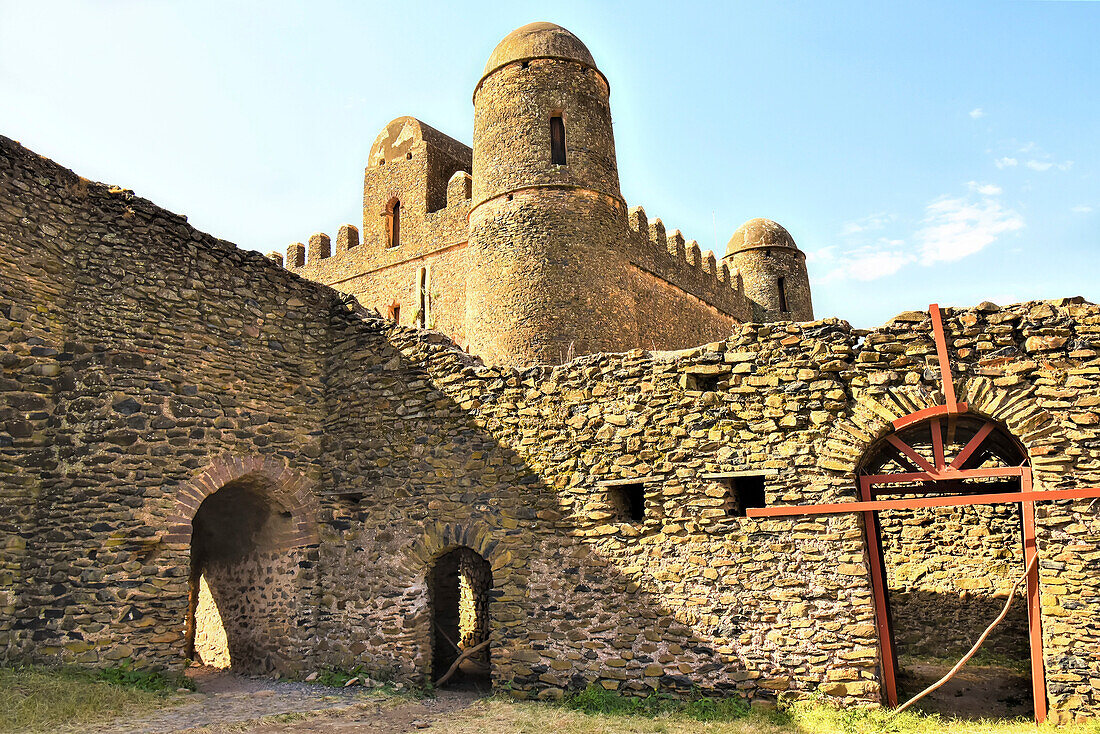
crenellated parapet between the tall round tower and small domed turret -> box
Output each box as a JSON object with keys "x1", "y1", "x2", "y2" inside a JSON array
[{"x1": 627, "y1": 206, "x2": 752, "y2": 320}]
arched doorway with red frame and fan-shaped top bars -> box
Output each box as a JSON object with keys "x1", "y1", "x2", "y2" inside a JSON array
[{"x1": 858, "y1": 414, "x2": 1042, "y2": 717}]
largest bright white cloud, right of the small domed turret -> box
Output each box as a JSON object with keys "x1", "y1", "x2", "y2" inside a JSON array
[{"x1": 914, "y1": 197, "x2": 1024, "y2": 265}]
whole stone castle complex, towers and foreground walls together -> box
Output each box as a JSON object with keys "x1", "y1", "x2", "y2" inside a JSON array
[{"x1": 0, "y1": 20, "x2": 1100, "y2": 721}]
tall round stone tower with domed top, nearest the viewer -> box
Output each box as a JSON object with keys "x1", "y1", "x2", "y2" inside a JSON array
[{"x1": 466, "y1": 23, "x2": 637, "y2": 364}]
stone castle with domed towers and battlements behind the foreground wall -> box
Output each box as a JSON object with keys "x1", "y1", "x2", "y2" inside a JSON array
[{"x1": 274, "y1": 23, "x2": 813, "y2": 364}]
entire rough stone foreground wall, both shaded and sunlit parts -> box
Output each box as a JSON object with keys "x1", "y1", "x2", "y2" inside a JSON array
[{"x1": 0, "y1": 139, "x2": 1100, "y2": 715}]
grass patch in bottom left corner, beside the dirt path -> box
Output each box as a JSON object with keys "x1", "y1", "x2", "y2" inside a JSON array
[{"x1": 0, "y1": 665, "x2": 189, "y2": 732}]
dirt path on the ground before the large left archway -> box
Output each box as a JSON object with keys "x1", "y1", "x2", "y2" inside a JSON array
[{"x1": 100, "y1": 668, "x2": 479, "y2": 734}]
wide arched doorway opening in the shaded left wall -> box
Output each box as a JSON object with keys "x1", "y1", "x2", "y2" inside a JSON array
[{"x1": 187, "y1": 472, "x2": 295, "y2": 673}]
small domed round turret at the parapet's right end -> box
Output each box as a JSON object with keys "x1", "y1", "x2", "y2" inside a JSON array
[{"x1": 724, "y1": 219, "x2": 814, "y2": 321}]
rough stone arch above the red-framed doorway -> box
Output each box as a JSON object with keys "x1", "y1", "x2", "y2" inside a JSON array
[{"x1": 821, "y1": 376, "x2": 1067, "y2": 489}]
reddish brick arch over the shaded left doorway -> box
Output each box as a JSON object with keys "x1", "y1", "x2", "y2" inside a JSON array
[{"x1": 164, "y1": 454, "x2": 318, "y2": 549}]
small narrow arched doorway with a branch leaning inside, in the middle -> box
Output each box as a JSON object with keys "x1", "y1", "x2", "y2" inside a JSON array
[{"x1": 428, "y1": 546, "x2": 493, "y2": 689}]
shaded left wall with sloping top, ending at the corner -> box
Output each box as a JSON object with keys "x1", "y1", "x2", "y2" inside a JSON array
[{"x1": 0, "y1": 138, "x2": 333, "y2": 665}]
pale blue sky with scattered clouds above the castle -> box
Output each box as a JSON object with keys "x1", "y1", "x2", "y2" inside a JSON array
[{"x1": 0, "y1": 0, "x2": 1100, "y2": 327}]
